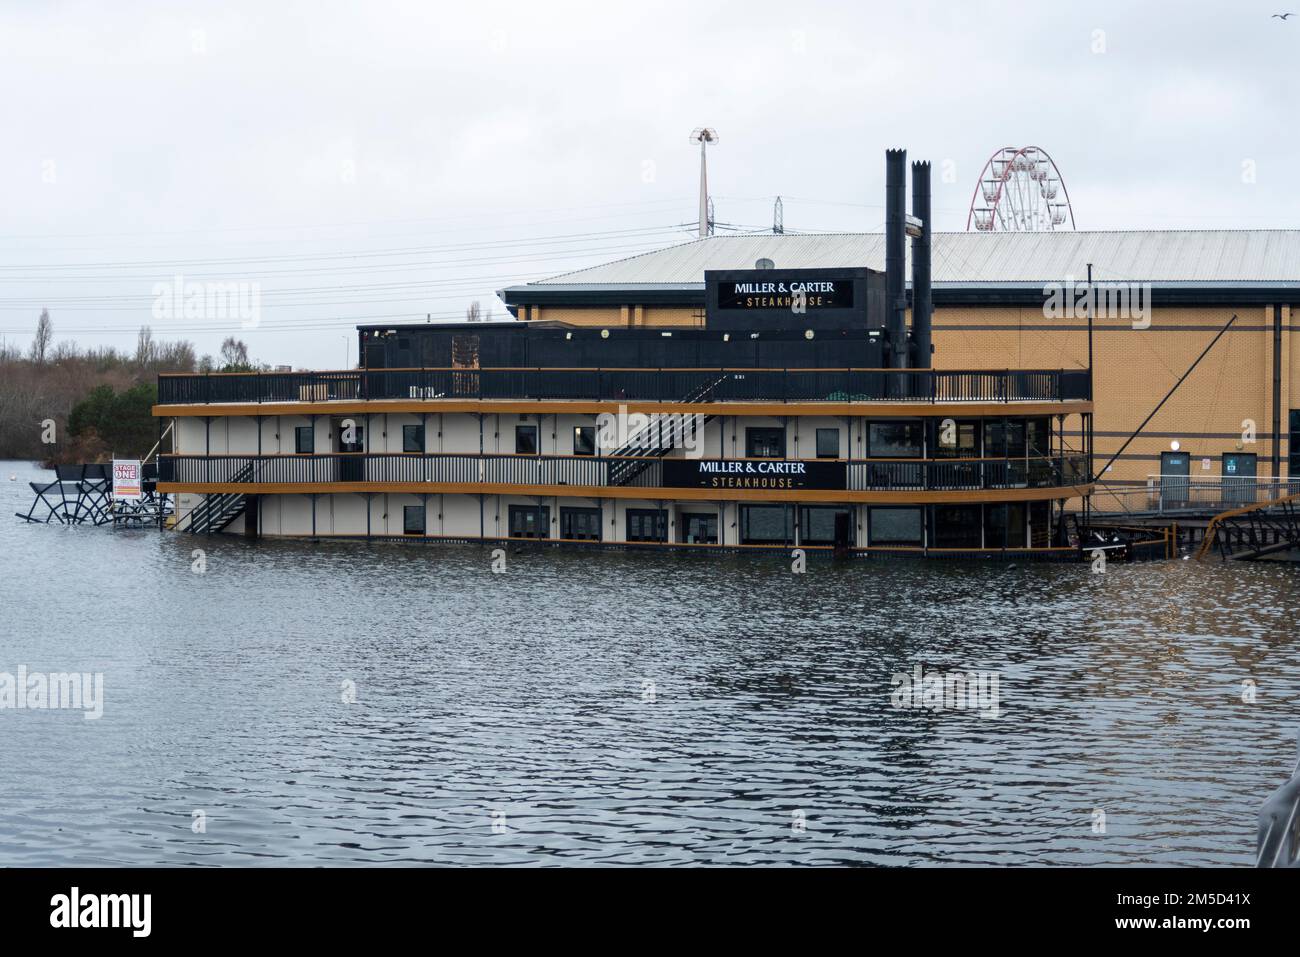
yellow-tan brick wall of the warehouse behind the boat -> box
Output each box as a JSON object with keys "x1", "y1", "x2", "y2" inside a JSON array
[{"x1": 529, "y1": 306, "x2": 1300, "y2": 482}]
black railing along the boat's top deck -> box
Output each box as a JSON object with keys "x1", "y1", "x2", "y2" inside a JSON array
[{"x1": 159, "y1": 369, "x2": 1088, "y2": 406}]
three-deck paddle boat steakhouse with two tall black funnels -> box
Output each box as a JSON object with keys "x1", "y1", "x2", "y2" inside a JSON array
[{"x1": 155, "y1": 151, "x2": 1092, "y2": 558}]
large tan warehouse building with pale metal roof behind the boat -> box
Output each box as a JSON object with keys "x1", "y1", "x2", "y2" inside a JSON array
[{"x1": 499, "y1": 230, "x2": 1300, "y2": 501}]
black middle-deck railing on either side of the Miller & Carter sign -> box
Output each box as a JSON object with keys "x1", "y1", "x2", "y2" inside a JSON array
[{"x1": 159, "y1": 452, "x2": 1087, "y2": 492}]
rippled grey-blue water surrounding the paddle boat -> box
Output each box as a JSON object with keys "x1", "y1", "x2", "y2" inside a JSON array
[{"x1": 0, "y1": 463, "x2": 1300, "y2": 866}]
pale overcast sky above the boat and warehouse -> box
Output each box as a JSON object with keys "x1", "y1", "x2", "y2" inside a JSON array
[{"x1": 0, "y1": 0, "x2": 1300, "y2": 368}]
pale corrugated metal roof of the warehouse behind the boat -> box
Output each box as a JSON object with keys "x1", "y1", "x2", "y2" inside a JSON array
[{"x1": 523, "y1": 229, "x2": 1300, "y2": 290}]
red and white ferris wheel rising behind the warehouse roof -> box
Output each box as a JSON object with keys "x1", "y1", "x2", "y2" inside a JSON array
[{"x1": 966, "y1": 146, "x2": 1074, "y2": 233}]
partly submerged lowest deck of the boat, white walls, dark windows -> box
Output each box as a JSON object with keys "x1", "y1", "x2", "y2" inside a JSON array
[{"x1": 174, "y1": 489, "x2": 1076, "y2": 557}]
